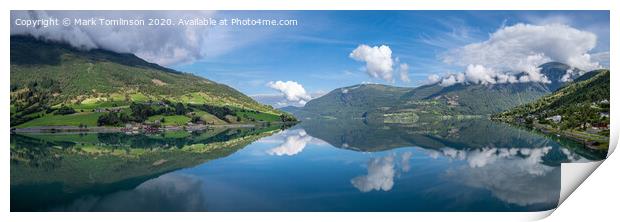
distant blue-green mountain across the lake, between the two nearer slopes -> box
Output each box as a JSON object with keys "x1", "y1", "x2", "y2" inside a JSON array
[{"x1": 285, "y1": 62, "x2": 580, "y2": 122}]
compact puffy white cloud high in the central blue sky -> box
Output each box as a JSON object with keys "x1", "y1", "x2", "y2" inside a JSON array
[{"x1": 349, "y1": 45, "x2": 394, "y2": 82}]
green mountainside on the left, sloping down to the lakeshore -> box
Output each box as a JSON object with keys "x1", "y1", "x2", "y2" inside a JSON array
[{"x1": 10, "y1": 36, "x2": 285, "y2": 126}]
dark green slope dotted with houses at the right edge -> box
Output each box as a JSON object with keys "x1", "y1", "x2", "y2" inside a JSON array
[{"x1": 493, "y1": 69, "x2": 610, "y2": 136}]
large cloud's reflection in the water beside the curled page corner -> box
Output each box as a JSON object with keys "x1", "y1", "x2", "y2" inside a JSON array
[{"x1": 431, "y1": 146, "x2": 574, "y2": 206}]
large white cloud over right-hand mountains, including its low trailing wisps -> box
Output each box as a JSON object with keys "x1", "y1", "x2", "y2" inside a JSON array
[{"x1": 429, "y1": 24, "x2": 605, "y2": 86}]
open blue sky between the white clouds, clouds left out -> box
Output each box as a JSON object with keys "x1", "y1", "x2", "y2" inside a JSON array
[{"x1": 173, "y1": 11, "x2": 609, "y2": 101}]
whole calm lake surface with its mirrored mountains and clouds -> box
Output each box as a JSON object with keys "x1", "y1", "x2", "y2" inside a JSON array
[{"x1": 11, "y1": 120, "x2": 605, "y2": 211}]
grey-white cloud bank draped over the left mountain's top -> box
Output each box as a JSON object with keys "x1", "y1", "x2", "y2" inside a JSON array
[{"x1": 11, "y1": 11, "x2": 223, "y2": 65}]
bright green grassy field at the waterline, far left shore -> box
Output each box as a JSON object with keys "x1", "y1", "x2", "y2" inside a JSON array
[{"x1": 17, "y1": 112, "x2": 103, "y2": 128}]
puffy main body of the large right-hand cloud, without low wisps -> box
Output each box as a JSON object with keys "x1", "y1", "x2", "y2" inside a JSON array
[{"x1": 444, "y1": 24, "x2": 598, "y2": 71}]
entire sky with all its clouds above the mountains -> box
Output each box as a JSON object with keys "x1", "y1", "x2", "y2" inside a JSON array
[{"x1": 11, "y1": 11, "x2": 609, "y2": 106}]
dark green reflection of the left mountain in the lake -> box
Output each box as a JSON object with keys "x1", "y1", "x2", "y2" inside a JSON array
[{"x1": 11, "y1": 126, "x2": 280, "y2": 211}]
